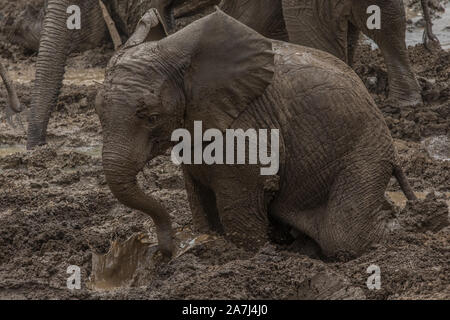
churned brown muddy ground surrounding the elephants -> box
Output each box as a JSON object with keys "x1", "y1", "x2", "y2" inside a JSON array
[{"x1": 0, "y1": 0, "x2": 450, "y2": 299}]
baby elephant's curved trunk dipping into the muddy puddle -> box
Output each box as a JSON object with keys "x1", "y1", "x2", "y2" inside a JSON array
[{"x1": 103, "y1": 142, "x2": 173, "y2": 257}]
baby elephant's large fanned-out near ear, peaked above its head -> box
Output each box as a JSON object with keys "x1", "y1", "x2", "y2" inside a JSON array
[{"x1": 159, "y1": 10, "x2": 274, "y2": 129}]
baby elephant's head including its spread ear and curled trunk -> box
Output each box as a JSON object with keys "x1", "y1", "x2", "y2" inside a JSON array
[{"x1": 96, "y1": 11, "x2": 274, "y2": 253}]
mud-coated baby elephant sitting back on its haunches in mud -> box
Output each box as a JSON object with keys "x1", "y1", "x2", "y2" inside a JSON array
[{"x1": 96, "y1": 11, "x2": 414, "y2": 255}]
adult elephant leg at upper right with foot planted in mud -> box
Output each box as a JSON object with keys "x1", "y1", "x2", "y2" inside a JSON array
[{"x1": 351, "y1": 0, "x2": 422, "y2": 106}]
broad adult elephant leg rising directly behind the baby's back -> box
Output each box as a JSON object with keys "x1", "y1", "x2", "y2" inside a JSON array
[{"x1": 282, "y1": 0, "x2": 351, "y2": 62}]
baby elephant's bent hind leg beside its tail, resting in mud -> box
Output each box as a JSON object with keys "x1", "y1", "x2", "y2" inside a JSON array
[{"x1": 315, "y1": 159, "x2": 392, "y2": 257}]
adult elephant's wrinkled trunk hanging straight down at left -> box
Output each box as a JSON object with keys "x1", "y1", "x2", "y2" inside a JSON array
[{"x1": 27, "y1": 0, "x2": 70, "y2": 149}]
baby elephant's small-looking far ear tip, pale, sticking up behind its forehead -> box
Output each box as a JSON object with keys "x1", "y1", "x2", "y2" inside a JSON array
[{"x1": 122, "y1": 9, "x2": 167, "y2": 49}]
